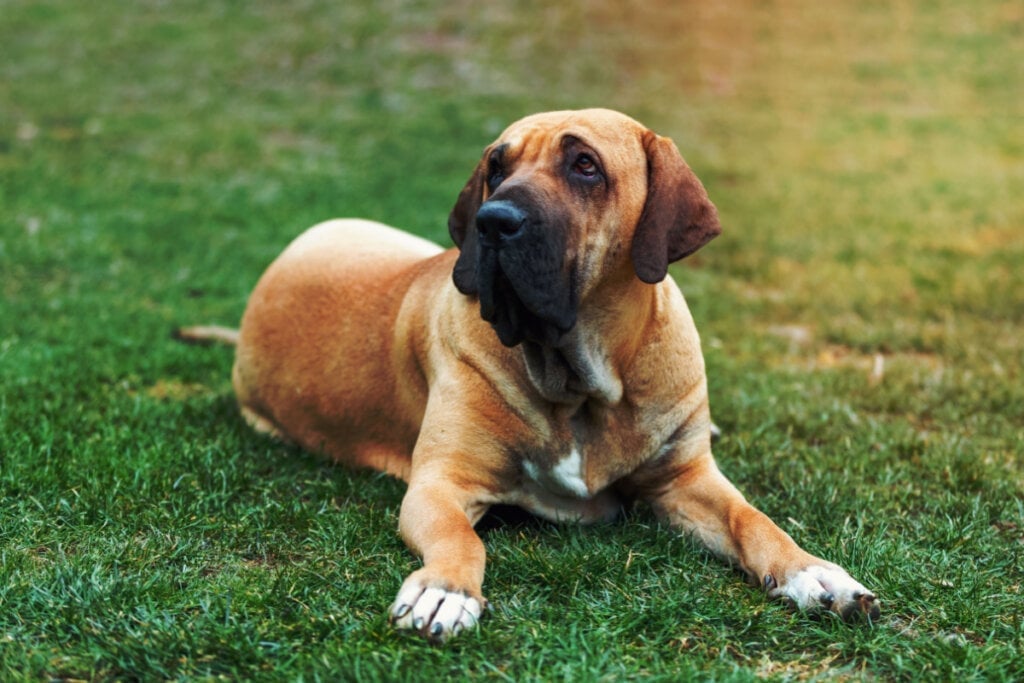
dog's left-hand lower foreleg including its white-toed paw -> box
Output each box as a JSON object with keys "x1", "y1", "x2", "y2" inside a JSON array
[{"x1": 390, "y1": 468, "x2": 486, "y2": 642}]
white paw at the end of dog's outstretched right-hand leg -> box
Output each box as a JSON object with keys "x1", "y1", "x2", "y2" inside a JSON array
[{"x1": 763, "y1": 564, "x2": 881, "y2": 622}]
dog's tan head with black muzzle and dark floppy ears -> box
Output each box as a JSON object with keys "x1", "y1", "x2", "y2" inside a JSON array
[{"x1": 449, "y1": 110, "x2": 721, "y2": 346}]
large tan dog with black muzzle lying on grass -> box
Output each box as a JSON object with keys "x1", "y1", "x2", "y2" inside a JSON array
[{"x1": 184, "y1": 110, "x2": 879, "y2": 640}]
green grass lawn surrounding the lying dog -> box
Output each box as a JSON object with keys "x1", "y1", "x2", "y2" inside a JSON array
[{"x1": 0, "y1": 0, "x2": 1024, "y2": 682}]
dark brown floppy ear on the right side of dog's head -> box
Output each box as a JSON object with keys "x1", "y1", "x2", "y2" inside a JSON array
[{"x1": 631, "y1": 131, "x2": 722, "y2": 284}]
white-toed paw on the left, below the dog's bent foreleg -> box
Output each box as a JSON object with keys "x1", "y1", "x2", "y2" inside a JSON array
[{"x1": 389, "y1": 573, "x2": 482, "y2": 643}]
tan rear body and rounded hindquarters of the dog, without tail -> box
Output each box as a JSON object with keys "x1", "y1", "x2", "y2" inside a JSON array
[{"x1": 232, "y1": 219, "x2": 442, "y2": 478}]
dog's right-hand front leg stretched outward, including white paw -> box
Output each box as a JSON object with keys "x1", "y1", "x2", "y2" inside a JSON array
[{"x1": 637, "y1": 451, "x2": 879, "y2": 620}]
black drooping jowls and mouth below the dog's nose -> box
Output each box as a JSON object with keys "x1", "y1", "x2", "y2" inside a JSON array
[{"x1": 477, "y1": 244, "x2": 577, "y2": 347}]
